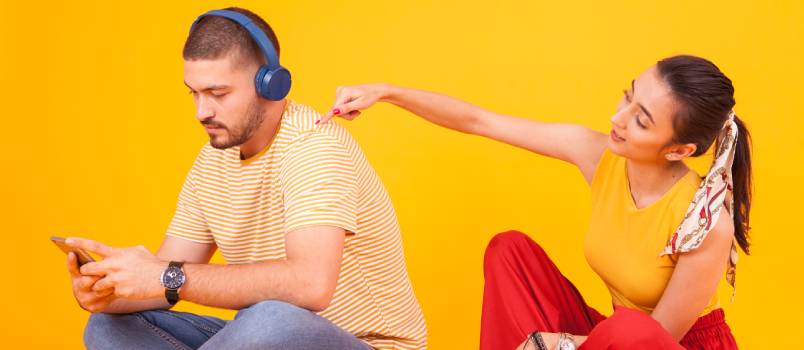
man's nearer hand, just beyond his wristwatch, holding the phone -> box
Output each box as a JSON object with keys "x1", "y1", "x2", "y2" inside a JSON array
[{"x1": 66, "y1": 237, "x2": 167, "y2": 300}]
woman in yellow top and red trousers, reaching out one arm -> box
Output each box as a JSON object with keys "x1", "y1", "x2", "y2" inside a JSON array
[{"x1": 320, "y1": 56, "x2": 751, "y2": 349}]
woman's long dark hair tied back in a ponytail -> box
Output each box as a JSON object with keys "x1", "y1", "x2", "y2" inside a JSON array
[{"x1": 656, "y1": 55, "x2": 752, "y2": 254}]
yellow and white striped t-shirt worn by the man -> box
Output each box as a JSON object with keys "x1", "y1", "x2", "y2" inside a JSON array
[{"x1": 167, "y1": 101, "x2": 427, "y2": 349}]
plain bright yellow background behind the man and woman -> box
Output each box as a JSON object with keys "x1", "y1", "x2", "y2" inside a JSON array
[{"x1": 0, "y1": 0, "x2": 804, "y2": 349}]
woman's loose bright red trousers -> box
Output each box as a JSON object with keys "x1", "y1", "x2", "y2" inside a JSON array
[{"x1": 480, "y1": 231, "x2": 737, "y2": 350}]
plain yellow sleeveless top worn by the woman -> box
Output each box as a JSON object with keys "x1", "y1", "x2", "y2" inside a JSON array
[{"x1": 584, "y1": 149, "x2": 720, "y2": 315}]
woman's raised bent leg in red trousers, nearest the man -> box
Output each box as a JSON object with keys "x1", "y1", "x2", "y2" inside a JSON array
[{"x1": 480, "y1": 231, "x2": 605, "y2": 350}]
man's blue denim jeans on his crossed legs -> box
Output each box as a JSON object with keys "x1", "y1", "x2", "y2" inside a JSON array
[{"x1": 84, "y1": 301, "x2": 371, "y2": 350}]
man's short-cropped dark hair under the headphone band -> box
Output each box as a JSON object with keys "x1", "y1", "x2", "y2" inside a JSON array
[{"x1": 182, "y1": 7, "x2": 279, "y2": 64}]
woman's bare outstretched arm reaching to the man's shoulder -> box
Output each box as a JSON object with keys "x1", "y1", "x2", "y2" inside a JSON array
[{"x1": 321, "y1": 84, "x2": 607, "y2": 182}]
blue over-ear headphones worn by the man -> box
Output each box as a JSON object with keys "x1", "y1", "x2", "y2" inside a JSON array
[{"x1": 190, "y1": 10, "x2": 290, "y2": 101}]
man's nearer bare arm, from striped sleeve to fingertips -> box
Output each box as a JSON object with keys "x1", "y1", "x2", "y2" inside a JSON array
[{"x1": 78, "y1": 226, "x2": 345, "y2": 313}]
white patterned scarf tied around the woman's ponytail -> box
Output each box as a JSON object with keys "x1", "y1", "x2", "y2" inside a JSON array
[{"x1": 659, "y1": 111, "x2": 738, "y2": 301}]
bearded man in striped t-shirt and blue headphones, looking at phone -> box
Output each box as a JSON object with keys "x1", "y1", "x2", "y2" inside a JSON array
[{"x1": 68, "y1": 8, "x2": 427, "y2": 349}]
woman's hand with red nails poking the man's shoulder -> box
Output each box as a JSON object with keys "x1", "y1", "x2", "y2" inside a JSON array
[{"x1": 316, "y1": 83, "x2": 389, "y2": 124}]
